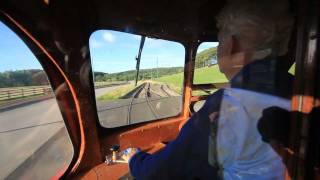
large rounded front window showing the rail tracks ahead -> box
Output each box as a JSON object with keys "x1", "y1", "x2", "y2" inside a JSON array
[{"x1": 90, "y1": 30, "x2": 185, "y2": 128}]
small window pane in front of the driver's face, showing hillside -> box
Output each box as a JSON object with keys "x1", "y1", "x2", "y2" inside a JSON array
[{"x1": 193, "y1": 42, "x2": 228, "y2": 84}]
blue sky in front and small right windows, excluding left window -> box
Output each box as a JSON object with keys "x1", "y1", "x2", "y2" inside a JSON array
[{"x1": 90, "y1": 30, "x2": 217, "y2": 73}]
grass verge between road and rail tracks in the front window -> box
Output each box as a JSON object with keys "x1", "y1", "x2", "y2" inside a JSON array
[{"x1": 98, "y1": 84, "x2": 134, "y2": 101}]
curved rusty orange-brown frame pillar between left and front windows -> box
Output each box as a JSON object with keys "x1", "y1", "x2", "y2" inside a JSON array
[{"x1": 0, "y1": 8, "x2": 102, "y2": 177}]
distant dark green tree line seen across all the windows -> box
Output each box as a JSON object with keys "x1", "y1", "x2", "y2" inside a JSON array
[{"x1": 0, "y1": 47, "x2": 217, "y2": 88}]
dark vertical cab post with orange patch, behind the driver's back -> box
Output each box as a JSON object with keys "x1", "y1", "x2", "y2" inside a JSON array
[{"x1": 286, "y1": 0, "x2": 320, "y2": 179}]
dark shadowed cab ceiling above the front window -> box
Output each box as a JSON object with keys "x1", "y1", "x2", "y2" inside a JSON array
[{"x1": 0, "y1": 0, "x2": 225, "y2": 42}]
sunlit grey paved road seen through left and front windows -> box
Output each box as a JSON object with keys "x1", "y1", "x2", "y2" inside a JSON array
[{"x1": 0, "y1": 87, "x2": 125, "y2": 179}]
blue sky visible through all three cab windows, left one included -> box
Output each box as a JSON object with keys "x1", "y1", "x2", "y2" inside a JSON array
[{"x1": 0, "y1": 22, "x2": 218, "y2": 73}]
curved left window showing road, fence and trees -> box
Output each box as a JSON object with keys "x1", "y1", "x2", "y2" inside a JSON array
[{"x1": 0, "y1": 22, "x2": 73, "y2": 179}]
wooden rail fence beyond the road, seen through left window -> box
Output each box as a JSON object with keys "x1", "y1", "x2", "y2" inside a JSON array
[{"x1": 0, "y1": 86, "x2": 52, "y2": 101}]
